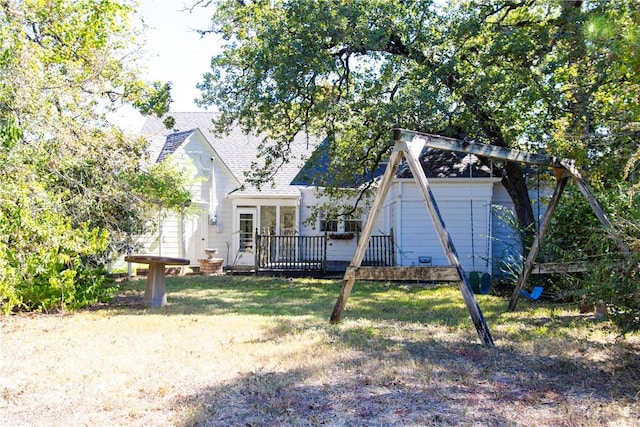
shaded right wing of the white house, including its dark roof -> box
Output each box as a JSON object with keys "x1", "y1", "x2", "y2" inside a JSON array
[{"x1": 382, "y1": 149, "x2": 501, "y2": 273}]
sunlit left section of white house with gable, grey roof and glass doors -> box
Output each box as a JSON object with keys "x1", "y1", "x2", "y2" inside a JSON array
[{"x1": 134, "y1": 112, "x2": 315, "y2": 266}]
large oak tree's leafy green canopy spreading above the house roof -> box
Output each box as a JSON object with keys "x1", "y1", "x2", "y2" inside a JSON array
[{"x1": 200, "y1": 0, "x2": 604, "y2": 226}]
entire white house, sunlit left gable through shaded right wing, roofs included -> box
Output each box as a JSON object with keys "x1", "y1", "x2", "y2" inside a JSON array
[{"x1": 129, "y1": 112, "x2": 512, "y2": 273}]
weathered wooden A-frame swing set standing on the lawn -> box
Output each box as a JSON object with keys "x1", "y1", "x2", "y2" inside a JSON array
[{"x1": 331, "y1": 129, "x2": 629, "y2": 348}]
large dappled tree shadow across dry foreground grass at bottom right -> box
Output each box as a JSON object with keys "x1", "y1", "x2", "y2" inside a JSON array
[{"x1": 170, "y1": 320, "x2": 640, "y2": 426}]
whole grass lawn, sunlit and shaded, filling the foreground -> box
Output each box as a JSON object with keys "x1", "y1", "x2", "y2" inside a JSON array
[{"x1": 0, "y1": 276, "x2": 640, "y2": 426}]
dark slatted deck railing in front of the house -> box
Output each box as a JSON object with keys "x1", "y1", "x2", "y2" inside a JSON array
[{"x1": 256, "y1": 234, "x2": 395, "y2": 271}]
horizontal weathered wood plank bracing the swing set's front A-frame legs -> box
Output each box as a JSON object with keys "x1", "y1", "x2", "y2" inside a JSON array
[{"x1": 344, "y1": 267, "x2": 460, "y2": 282}]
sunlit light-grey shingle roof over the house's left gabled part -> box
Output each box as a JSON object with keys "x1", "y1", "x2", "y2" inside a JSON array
[{"x1": 141, "y1": 112, "x2": 317, "y2": 196}]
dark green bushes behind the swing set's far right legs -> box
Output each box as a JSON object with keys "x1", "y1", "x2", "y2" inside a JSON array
[{"x1": 542, "y1": 185, "x2": 640, "y2": 332}]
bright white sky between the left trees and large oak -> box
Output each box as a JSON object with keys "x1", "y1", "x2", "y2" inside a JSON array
[{"x1": 110, "y1": 0, "x2": 219, "y2": 131}]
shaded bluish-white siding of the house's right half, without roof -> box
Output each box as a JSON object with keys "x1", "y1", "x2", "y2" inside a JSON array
[{"x1": 301, "y1": 179, "x2": 495, "y2": 272}]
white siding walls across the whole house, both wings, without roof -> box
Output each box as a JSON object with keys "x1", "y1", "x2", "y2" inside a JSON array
[{"x1": 117, "y1": 127, "x2": 528, "y2": 274}]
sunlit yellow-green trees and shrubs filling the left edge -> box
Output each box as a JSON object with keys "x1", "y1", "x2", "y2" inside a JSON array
[{"x1": 0, "y1": 0, "x2": 184, "y2": 313}]
